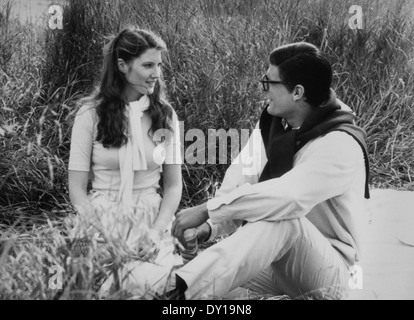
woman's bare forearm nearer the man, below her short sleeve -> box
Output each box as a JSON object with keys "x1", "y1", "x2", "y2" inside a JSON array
[{"x1": 154, "y1": 164, "x2": 183, "y2": 231}]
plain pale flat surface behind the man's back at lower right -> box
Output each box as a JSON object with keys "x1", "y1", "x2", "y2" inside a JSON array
[{"x1": 350, "y1": 190, "x2": 414, "y2": 300}]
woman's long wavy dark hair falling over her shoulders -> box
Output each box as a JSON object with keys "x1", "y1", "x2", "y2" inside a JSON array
[{"x1": 84, "y1": 27, "x2": 173, "y2": 148}]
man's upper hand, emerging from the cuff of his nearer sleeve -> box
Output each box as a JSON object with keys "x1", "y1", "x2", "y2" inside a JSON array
[{"x1": 171, "y1": 203, "x2": 208, "y2": 246}]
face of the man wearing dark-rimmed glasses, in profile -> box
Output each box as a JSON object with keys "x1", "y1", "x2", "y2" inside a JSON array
[{"x1": 266, "y1": 65, "x2": 295, "y2": 119}]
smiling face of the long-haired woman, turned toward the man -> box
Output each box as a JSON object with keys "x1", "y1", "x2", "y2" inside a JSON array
[{"x1": 120, "y1": 49, "x2": 162, "y2": 101}]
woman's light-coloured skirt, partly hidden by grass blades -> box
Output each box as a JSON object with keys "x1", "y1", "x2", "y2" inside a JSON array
[{"x1": 71, "y1": 189, "x2": 183, "y2": 299}]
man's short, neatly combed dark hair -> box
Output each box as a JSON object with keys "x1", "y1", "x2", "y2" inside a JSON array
[{"x1": 269, "y1": 42, "x2": 332, "y2": 107}]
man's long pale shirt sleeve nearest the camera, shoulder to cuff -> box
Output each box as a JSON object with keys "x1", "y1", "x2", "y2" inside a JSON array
[{"x1": 207, "y1": 131, "x2": 363, "y2": 225}]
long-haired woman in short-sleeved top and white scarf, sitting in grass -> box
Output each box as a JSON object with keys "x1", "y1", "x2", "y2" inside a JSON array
[{"x1": 69, "y1": 27, "x2": 182, "y2": 296}]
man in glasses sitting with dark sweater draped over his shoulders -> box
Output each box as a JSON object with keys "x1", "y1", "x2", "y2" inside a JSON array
[{"x1": 172, "y1": 43, "x2": 369, "y2": 299}]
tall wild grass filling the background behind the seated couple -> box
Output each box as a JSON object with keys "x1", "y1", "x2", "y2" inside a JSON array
[{"x1": 0, "y1": 0, "x2": 414, "y2": 299}]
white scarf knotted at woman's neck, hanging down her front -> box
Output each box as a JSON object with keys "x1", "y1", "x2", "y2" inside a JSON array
[{"x1": 118, "y1": 95, "x2": 150, "y2": 206}]
